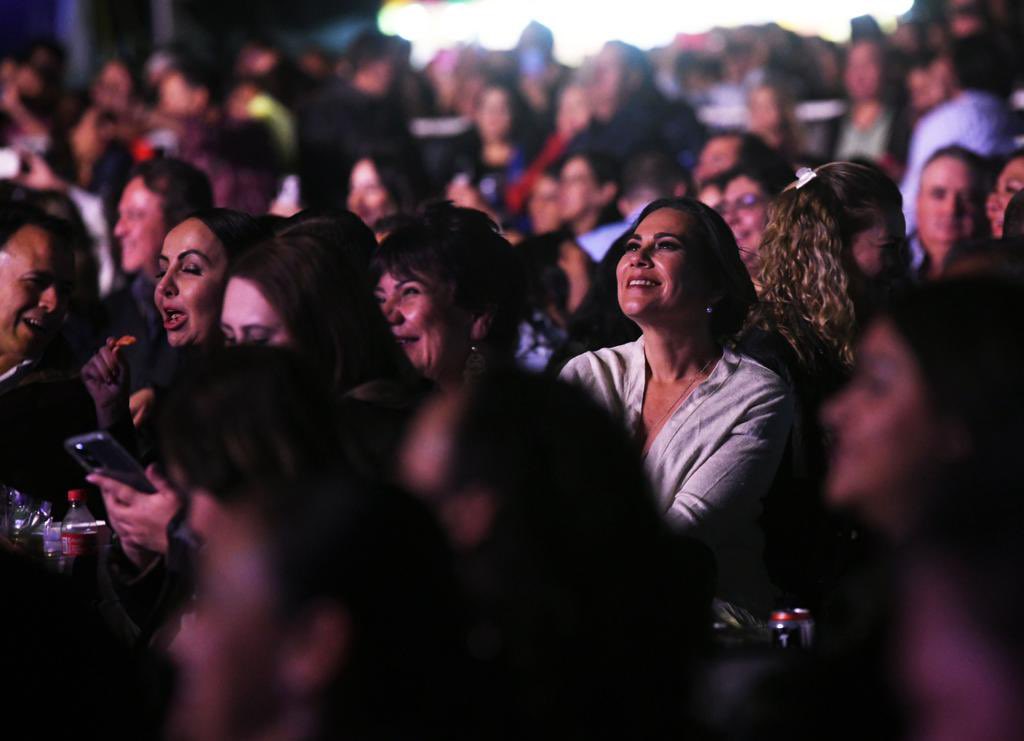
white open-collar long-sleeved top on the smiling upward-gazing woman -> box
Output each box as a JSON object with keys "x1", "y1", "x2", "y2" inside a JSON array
[{"x1": 561, "y1": 337, "x2": 794, "y2": 617}]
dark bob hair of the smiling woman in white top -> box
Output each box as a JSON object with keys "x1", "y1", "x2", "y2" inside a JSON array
[{"x1": 627, "y1": 199, "x2": 758, "y2": 340}]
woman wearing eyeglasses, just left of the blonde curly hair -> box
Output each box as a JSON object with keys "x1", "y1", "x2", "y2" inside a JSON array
[{"x1": 706, "y1": 163, "x2": 793, "y2": 292}]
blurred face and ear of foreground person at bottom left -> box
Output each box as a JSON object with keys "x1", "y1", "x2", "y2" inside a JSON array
[{"x1": 171, "y1": 503, "x2": 352, "y2": 741}]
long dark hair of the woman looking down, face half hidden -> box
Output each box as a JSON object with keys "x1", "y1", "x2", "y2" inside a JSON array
[{"x1": 228, "y1": 236, "x2": 408, "y2": 395}]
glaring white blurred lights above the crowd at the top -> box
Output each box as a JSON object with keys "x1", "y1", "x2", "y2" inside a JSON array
[{"x1": 378, "y1": 0, "x2": 913, "y2": 64}]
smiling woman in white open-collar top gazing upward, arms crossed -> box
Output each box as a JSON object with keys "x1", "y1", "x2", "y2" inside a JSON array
[{"x1": 562, "y1": 199, "x2": 794, "y2": 612}]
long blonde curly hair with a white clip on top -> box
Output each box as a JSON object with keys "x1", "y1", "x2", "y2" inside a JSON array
[{"x1": 749, "y1": 162, "x2": 902, "y2": 373}]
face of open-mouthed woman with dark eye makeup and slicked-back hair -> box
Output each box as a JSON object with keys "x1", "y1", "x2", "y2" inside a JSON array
[{"x1": 154, "y1": 219, "x2": 227, "y2": 347}]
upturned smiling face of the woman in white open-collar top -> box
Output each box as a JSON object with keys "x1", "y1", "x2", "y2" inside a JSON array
[{"x1": 615, "y1": 209, "x2": 714, "y2": 325}]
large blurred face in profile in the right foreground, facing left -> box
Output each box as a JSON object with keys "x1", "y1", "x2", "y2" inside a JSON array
[{"x1": 822, "y1": 321, "x2": 950, "y2": 537}]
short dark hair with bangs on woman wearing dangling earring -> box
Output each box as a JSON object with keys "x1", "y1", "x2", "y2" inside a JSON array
[{"x1": 371, "y1": 202, "x2": 524, "y2": 356}]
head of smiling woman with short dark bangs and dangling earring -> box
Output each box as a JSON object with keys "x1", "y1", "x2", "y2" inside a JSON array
[{"x1": 371, "y1": 203, "x2": 524, "y2": 389}]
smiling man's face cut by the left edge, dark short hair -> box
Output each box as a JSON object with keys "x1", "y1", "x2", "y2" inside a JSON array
[{"x1": 0, "y1": 225, "x2": 75, "y2": 371}]
